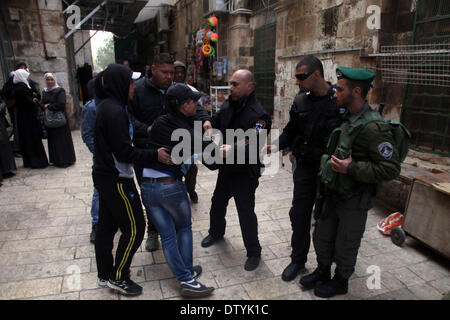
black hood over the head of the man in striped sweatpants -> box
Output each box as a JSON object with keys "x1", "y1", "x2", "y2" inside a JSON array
[{"x1": 103, "y1": 64, "x2": 133, "y2": 106}]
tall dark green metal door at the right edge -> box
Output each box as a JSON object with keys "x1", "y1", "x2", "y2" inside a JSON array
[{"x1": 402, "y1": 0, "x2": 450, "y2": 156}]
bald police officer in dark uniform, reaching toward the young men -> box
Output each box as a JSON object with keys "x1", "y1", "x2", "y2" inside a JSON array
[{"x1": 202, "y1": 70, "x2": 272, "y2": 271}]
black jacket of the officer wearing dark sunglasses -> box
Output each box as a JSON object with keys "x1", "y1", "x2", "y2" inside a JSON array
[{"x1": 279, "y1": 86, "x2": 342, "y2": 167}]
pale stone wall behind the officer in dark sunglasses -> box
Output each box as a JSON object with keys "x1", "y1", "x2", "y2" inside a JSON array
[{"x1": 273, "y1": 0, "x2": 382, "y2": 128}]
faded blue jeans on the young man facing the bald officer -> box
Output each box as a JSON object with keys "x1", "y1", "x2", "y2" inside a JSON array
[{"x1": 141, "y1": 181, "x2": 193, "y2": 281}]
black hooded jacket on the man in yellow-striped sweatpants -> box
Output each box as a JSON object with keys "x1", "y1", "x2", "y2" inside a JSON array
[{"x1": 93, "y1": 64, "x2": 158, "y2": 179}]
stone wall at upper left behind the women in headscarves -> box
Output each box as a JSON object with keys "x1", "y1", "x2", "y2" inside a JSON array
[{"x1": 1, "y1": 0, "x2": 92, "y2": 125}]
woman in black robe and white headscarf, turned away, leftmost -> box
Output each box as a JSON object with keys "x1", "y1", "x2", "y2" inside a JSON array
[{"x1": 13, "y1": 69, "x2": 48, "y2": 169}]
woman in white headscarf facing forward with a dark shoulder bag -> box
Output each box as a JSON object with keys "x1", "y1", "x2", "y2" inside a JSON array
[{"x1": 41, "y1": 73, "x2": 76, "y2": 168}]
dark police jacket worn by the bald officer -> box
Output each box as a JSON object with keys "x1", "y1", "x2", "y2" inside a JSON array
[{"x1": 211, "y1": 92, "x2": 272, "y2": 177}]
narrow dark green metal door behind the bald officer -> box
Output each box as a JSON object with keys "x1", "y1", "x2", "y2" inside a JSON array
[{"x1": 253, "y1": 23, "x2": 276, "y2": 115}]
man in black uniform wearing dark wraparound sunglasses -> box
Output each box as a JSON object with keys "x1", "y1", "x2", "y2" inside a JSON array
[{"x1": 267, "y1": 56, "x2": 341, "y2": 281}]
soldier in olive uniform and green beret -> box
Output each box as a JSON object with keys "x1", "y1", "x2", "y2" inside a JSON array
[{"x1": 300, "y1": 67, "x2": 400, "y2": 298}]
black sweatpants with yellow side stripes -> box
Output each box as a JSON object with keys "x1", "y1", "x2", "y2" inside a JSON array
[{"x1": 93, "y1": 174, "x2": 145, "y2": 280}]
